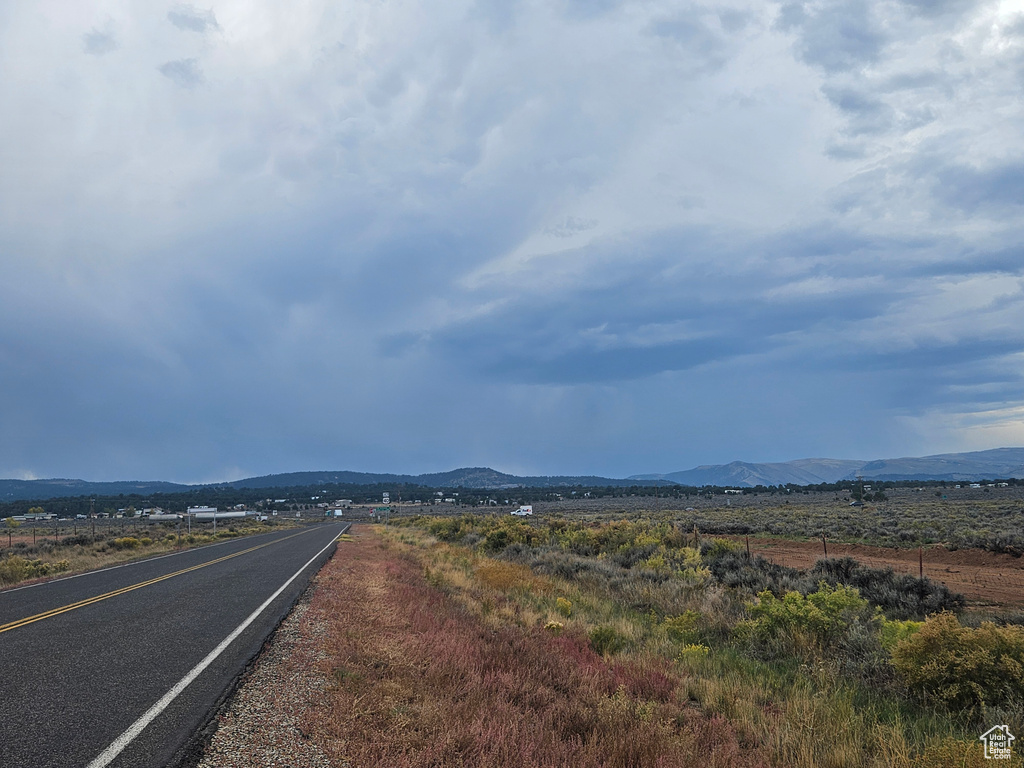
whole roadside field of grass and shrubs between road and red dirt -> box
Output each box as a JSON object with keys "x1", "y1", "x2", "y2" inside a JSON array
[{"x1": 204, "y1": 513, "x2": 1024, "y2": 768}]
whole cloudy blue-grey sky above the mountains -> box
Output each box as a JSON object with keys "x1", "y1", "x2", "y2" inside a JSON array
[{"x1": 0, "y1": 0, "x2": 1024, "y2": 482}]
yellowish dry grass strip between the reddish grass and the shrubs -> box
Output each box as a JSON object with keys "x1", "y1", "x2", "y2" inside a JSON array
[{"x1": 403, "y1": 529, "x2": 1021, "y2": 768}]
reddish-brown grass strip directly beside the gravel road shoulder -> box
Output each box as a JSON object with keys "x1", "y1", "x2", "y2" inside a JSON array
[{"x1": 303, "y1": 528, "x2": 767, "y2": 768}]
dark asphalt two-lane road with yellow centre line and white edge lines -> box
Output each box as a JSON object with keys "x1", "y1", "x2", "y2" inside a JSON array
[{"x1": 0, "y1": 522, "x2": 347, "y2": 768}]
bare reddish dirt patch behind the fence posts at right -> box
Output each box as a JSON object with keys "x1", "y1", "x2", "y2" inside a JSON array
[{"x1": 730, "y1": 537, "x2": 1024, "y2": 608}]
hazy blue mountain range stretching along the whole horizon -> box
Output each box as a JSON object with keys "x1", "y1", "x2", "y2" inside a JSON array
[{"x1": 0, "y1": 447, "x2": 1024, "y2": 501}]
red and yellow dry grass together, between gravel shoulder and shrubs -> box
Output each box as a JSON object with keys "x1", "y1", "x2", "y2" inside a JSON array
[{"x1": 282, "y1": 527, "x2": 1020, "y2": 768}]
